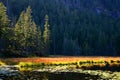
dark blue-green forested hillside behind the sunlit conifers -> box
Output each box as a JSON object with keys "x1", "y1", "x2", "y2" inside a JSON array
[{"x1": 0, "y1": 0, "x2": 120, "y2": 56}]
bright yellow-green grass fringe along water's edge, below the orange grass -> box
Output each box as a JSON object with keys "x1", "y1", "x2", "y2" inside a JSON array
[{"x1": 18, "y1": 60, "x2": 120, "y2": 69}]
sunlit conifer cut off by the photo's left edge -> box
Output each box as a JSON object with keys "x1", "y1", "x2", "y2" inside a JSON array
[{"x1": 0, "y1": 3, "x2": 13, "y2": 49}]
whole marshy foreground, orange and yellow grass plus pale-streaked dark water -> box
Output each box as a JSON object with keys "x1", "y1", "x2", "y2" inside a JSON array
[{"x1": 0, "y1": 57, "x2": 120, "y2": 80}]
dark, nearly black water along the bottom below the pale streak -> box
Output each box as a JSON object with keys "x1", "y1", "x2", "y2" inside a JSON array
[{"x1": 0, "y1": 71, "x2": 100, "y2": 80}]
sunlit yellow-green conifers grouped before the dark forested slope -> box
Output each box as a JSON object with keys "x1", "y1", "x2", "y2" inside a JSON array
[{"x1": 0, "y1": 3, "x2": 50, "y2": 57}]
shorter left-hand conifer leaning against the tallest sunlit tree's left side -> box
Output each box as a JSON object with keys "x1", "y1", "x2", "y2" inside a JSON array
[{"x1": 14, "y1": 11, "x2": 26, "y2": 49}]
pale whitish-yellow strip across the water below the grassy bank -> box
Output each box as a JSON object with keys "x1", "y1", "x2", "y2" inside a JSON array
[{"x1": 0, "y1": 66, "x2": 120, "y2": 80}]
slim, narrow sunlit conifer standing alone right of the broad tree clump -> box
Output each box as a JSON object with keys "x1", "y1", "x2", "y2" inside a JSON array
[{"x1": 43, "y1": 15, "x2": 50, "y2": 54}]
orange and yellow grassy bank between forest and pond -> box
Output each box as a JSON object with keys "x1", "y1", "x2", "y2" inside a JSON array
[{"x1": 0, "y1": 57, "x2": 120, "y2": 71}]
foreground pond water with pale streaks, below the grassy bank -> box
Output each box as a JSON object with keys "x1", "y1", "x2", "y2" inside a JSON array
[{"x1": 0, "y1": 67, "x2": 120, "y2": 80}]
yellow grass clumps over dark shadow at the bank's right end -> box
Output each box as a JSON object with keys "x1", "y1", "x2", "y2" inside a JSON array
[{"x1": 76, "y1": 60, "x2": 120, "y2": 70}]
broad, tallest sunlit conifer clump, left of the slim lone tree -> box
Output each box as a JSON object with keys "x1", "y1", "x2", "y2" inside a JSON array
[{"x1": 14, "y1": 7, "x2": 37, "y2": 52}]
